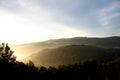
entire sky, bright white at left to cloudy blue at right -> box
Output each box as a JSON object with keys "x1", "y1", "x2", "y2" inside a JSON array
[{"x1": 0, "y1": 0, "x2": 120, "y2": 44}]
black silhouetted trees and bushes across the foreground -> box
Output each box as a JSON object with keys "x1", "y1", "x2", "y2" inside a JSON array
[{"x1": 0, "y1": 44, "x2": 120, "y2": 80}]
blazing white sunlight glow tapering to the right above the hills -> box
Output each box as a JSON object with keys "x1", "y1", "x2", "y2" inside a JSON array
[{"x1": 0, "y1": 11, "x2": 87, "y2": 44}]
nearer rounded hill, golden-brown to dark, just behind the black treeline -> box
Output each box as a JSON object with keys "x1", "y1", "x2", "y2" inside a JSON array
[{"x1": 28, "y1": 45, "x2": 120, "y2": 66}]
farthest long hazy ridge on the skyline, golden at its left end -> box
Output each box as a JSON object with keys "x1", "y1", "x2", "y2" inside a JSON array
[{"x1": 12, "y1": 36, "x2": 120, "y2": 54}]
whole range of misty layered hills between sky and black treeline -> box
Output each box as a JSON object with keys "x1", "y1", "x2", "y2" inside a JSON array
[{"x1": 13, "y1": 36, "x2": 120, "y2": 66}]
